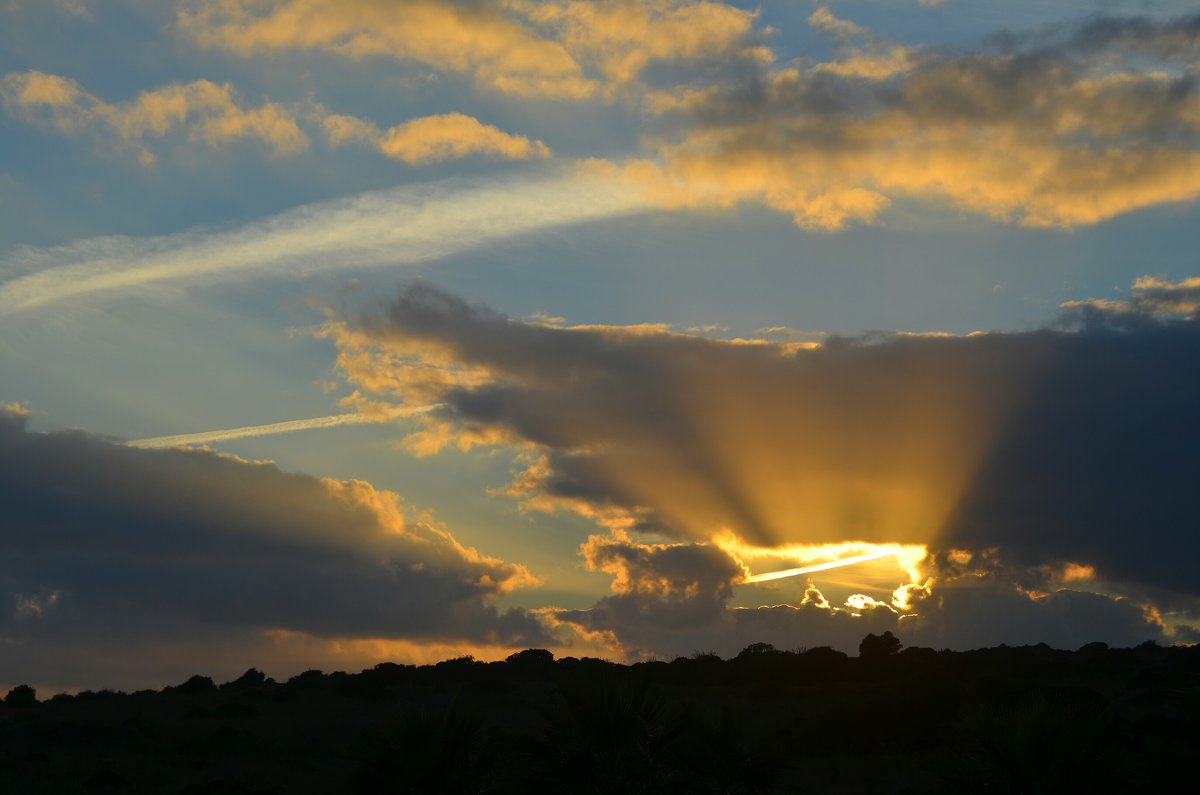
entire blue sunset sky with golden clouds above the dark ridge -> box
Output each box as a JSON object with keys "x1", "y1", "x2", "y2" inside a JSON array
[{"x1": 0, "y1": 0, "x2": 1200, "y2": 691}]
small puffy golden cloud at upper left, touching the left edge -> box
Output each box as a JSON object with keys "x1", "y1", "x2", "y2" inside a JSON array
[{"x1": 0, "y1": 70, "x2": 308, "y2": 166}]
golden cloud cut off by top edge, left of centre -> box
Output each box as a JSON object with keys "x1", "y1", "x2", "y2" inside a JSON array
[{"x1": 178, "y1": 0, "x2": 770, "y2": 100}]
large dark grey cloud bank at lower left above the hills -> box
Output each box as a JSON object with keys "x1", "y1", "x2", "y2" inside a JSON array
[{"x1": 0, "y1": 414, "x2": 548, "y2": 685}]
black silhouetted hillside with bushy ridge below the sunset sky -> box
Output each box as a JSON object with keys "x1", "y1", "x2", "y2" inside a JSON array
[{"x1": 0, "y1": 636, "x2": 1200, "y2": 795}]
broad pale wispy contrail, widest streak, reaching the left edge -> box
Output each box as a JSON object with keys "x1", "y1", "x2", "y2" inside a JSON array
[{"x1": 0, "y1": 171, "x2": 649, "y2": 313}]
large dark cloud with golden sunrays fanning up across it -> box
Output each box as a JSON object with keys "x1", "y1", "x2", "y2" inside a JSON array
[{"x1": 328, "y1": 280, "x2": 1200, "y2": 607}]
